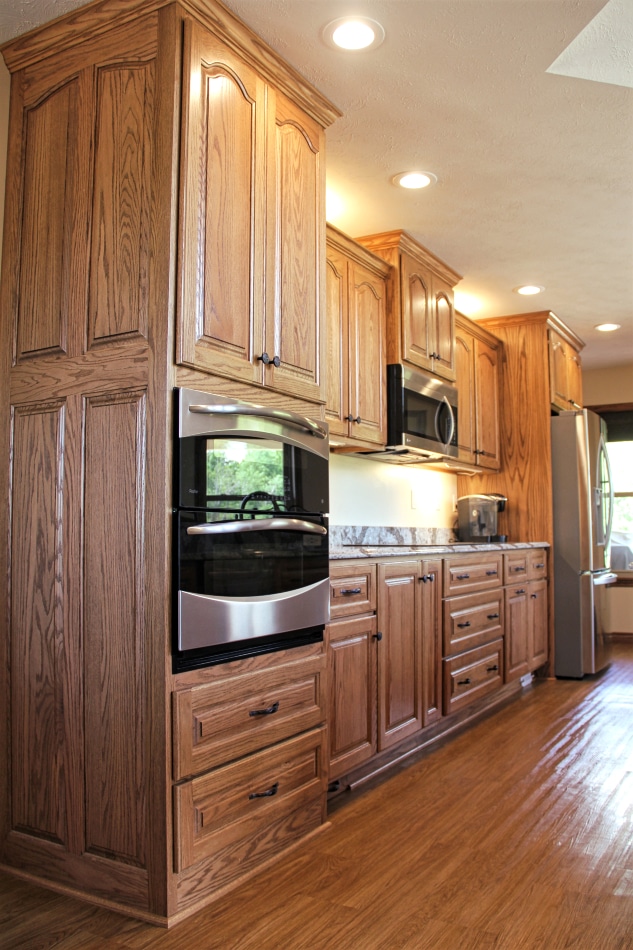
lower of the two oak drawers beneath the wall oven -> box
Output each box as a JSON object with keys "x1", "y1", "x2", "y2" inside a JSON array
[{"x1": 174, "y1": 728, "x2": 326, "y2": 872}]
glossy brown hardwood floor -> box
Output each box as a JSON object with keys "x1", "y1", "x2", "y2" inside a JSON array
[{"x1": 0, "y1": 643, "x2": 633, "y2": 950}]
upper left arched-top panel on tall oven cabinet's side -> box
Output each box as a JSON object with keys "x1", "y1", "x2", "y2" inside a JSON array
[{"x1": 16, "y1": 79, "x2": 79, "y2": 360}]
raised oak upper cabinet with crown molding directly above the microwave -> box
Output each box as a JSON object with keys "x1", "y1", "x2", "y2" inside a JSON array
[{"x1": 358, "y1": 231, "x2": 461, "y2": 380}]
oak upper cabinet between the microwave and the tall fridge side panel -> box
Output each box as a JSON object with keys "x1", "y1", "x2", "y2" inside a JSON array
[{"x1": 455, "y1": 313, "x2": 502, "y2": 471}]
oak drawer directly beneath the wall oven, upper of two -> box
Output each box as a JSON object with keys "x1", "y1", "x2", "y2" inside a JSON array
[{"x1": 173, "y1": 654, "x2": 327, "y2": 781}]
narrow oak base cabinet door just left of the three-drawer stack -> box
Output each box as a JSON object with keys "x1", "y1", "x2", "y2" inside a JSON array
[{"x1": 420, "y1": 558, "x2": 442, "y2": 726}]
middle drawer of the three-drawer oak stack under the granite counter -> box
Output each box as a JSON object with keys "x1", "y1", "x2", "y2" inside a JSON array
[{"x1": 444, "y1": 588, "x2": 504, "y2": 656}]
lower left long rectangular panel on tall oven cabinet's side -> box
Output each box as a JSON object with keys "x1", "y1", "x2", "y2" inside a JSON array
[{"x1": 10, "y1": 402, "x2": 68, "y2": 843}]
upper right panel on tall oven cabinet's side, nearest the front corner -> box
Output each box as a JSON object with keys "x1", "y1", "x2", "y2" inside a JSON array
[{"x1": 88, "y1": 62, "x2": 155, "y2": 344}]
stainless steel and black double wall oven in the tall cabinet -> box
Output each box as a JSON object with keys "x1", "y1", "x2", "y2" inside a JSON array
[{"x1": 173, "y1": 389, "x2": 329, "y2": 672}]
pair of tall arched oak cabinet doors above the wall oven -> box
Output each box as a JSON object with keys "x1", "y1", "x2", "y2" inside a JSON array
[{"x1": 177, "y1": 22, "x2": 336, "y2": 402}]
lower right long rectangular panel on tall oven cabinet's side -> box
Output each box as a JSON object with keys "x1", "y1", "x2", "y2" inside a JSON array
[{"x1": 83, "y1": 392, "x2": 147, "y2": 866}]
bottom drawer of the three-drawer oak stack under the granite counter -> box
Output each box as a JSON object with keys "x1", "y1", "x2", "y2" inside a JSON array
[{"x1": 443, "y1": 640, "x2": 503, "y2": 715}]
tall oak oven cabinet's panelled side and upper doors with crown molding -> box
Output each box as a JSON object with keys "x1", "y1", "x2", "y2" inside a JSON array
[{"x1": 0, "y1": 0, "x2": 338, "y2": 922}]
